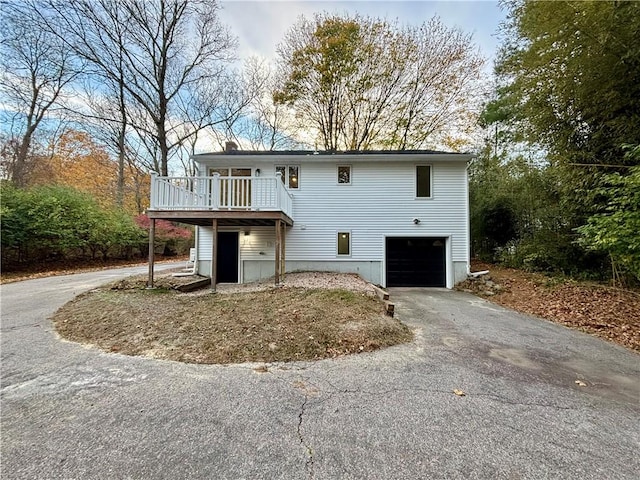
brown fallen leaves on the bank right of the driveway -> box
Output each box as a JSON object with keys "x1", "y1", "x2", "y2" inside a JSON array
[{"x1": 459, "y1": 264, "x2": 640, "y2": 352}]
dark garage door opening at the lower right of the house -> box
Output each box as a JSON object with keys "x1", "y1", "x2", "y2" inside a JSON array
[{"x1": 387, "y1": 237, "x2": 446, "y2": 287}]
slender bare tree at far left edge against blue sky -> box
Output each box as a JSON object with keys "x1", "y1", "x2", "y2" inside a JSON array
[{"x1": 0, "y1": 1, "x2": 82, "y2": 186}]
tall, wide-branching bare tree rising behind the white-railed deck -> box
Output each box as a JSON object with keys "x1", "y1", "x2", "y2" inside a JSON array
[{"x1": 39, "y1": 0, "x2": 240, "y2": 175}]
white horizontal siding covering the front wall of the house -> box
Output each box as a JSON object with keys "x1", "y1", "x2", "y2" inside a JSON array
[{"x1": 192, "y1": 157, "x2": 469, "y2": 284}]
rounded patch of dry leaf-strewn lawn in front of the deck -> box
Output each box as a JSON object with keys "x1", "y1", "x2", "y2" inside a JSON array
[{"x1": 53, "y1": 279, "x2": 413, "y2": 364}]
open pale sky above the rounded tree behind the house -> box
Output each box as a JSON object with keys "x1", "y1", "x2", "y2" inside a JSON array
[{"x1": 220, "y1": 0, "x2": 505, "y2": 68}]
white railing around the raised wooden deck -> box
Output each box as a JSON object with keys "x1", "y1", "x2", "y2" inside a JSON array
[{"x1": 149, "y1": 173, "x2": 293, "y2": 216}]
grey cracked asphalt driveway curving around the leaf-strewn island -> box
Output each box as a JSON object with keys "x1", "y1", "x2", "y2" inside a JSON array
[{"x1": 0, "y1": 269, "x2": 640, "y2": 479}]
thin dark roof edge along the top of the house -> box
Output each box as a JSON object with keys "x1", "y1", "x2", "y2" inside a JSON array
[{"x1": 191, "y1": 150, "x2": 475, "y2": 162}]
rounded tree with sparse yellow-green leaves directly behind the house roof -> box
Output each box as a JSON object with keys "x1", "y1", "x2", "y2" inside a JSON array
[{"x1": 274, "y1": 13, "x2": 483, "y2": 150}]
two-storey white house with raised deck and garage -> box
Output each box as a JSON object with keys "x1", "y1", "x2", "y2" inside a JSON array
[{"x1": 147, "y1": 146, "x2": 472, "y2": 288}]
